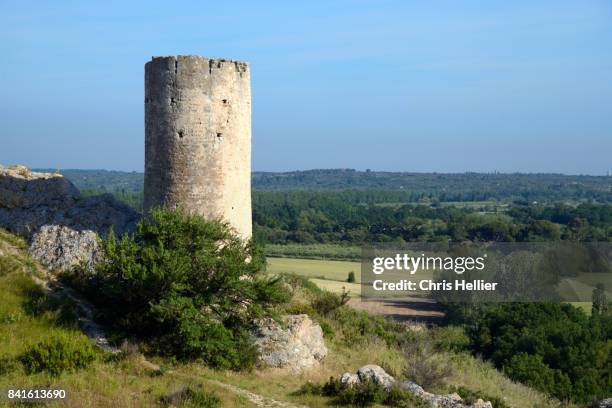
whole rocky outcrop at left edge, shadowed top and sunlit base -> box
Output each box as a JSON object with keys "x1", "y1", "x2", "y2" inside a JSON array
[{"x1": 0, "y1": 166, "x2": 140, "y2": 270}]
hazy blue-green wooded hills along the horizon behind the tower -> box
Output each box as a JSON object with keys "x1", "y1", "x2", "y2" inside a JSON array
[{"x1": 35, "y1": 169, "x2": 612, "y2": 202}]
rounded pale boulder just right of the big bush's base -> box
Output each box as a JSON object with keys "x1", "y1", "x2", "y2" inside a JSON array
[{"x1": 252, "y1": 314, "x2": 327, "y2": 372}]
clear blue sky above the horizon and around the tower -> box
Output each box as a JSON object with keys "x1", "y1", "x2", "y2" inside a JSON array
[{"x1": 0, "y1": 0, "x2": 612, "y2": 174}]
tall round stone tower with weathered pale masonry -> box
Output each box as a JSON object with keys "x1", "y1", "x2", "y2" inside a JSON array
[{"x1": 144, "y1": 56, "x2": 252, "y2": 238}]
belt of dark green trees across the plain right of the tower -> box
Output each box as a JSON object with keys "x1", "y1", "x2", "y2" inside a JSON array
[{"x1": 253, "y1": 191, "x2": 612, "y2": 244}]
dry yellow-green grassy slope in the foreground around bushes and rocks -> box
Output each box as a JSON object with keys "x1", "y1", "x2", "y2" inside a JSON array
[{"x1": 0, "y1": 231, "x2": 576, "y2": 407}]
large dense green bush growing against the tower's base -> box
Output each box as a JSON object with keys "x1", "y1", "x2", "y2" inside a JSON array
[{"x1": 83, "y1": 209, "x2": 288, "y2": 369}]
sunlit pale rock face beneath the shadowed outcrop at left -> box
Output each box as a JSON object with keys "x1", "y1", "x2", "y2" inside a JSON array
[{"x1": 29, "y1": 225, "x2": 99, "y2": 271}]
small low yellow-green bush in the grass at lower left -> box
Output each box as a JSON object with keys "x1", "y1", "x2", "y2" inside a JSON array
[{"x1": 20, "y1": 335, "x2": 96, "y2": 375}]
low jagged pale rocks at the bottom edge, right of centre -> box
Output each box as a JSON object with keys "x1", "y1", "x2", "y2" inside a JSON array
[{"x1": 340, "y1": 364, "x2": 493, "y2": 408}]
